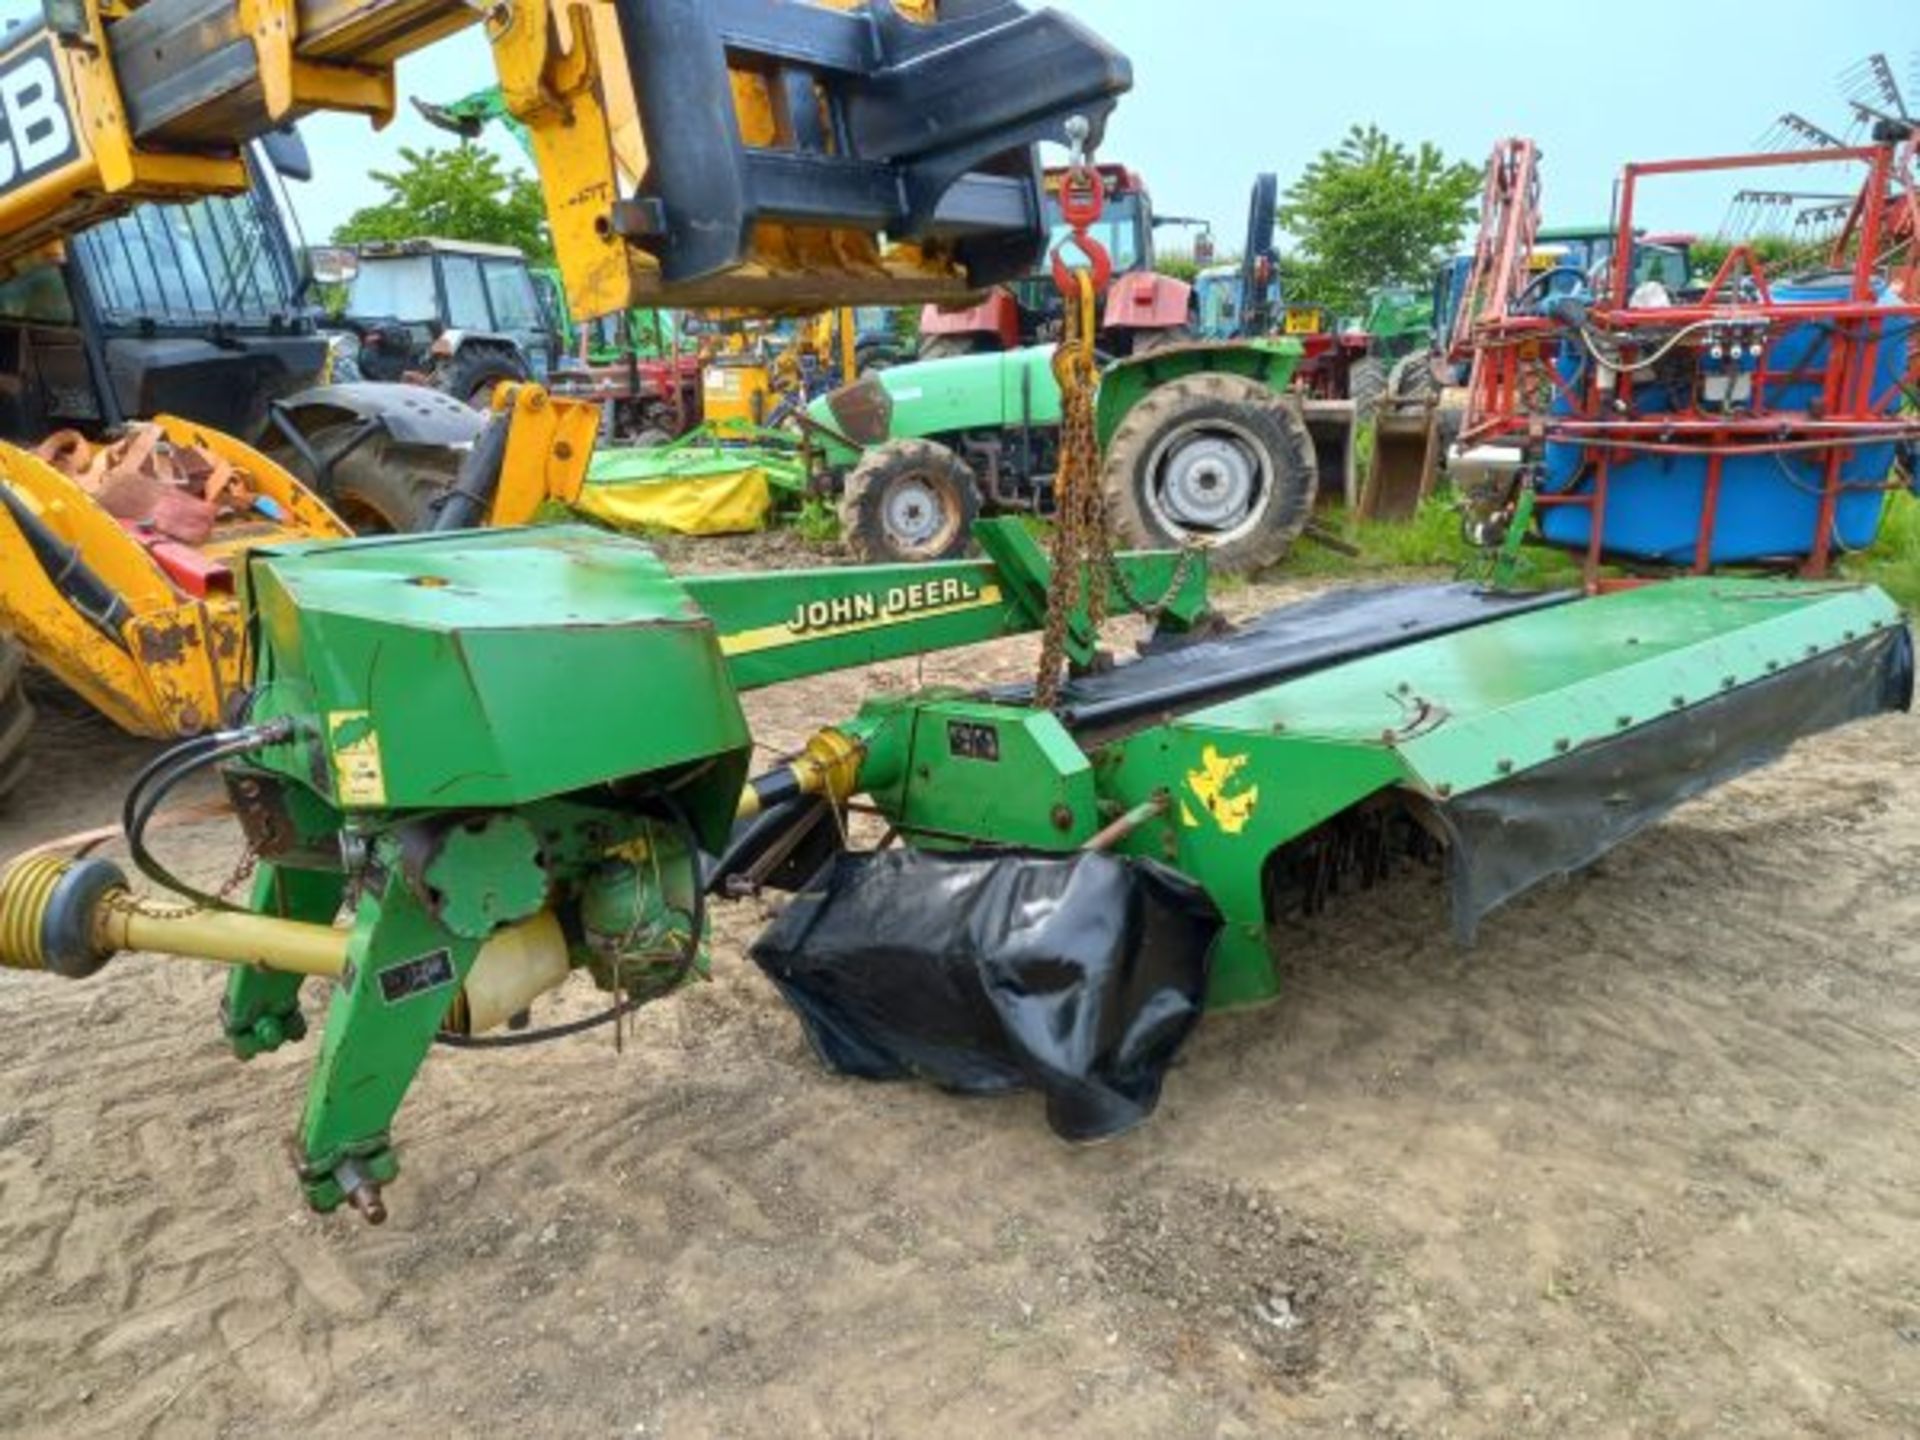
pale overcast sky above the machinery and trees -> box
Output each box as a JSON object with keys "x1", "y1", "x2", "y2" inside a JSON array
[{"x1": 0, "y1": 0, "x2": 1920, "y2": 250}]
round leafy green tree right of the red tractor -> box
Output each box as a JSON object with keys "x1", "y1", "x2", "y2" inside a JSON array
[{"x1": 1281, "y1": 125, "x2": 1480, "y2": 313}]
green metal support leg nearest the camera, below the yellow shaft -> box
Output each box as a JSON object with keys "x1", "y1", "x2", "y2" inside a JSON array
[{"x1": 300, "y1": 874, "x2": 480, "y2": 1221}]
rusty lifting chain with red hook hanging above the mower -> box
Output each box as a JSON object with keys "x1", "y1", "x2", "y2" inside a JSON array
[{"x1": 1033, "y1": 115, "x2": 1114, "y2": 708}]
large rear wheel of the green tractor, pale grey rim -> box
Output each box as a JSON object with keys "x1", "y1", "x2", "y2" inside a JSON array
[{"x1": 1102, "y1": 374, "x2": 1319, "y2": 574}]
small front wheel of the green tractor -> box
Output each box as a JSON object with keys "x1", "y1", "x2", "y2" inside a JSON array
[{"x1": 841, "y1": 440, "x2": 979, "y2": 564}]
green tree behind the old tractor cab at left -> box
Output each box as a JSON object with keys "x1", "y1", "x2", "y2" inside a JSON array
[{"x1": 334, "y1": 144, "x2": 553, "y2": 265}]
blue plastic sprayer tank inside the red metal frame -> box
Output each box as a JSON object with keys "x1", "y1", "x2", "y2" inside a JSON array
[{"x1": 1540, "y1": 275, "x2": 1912, "y2": 564}]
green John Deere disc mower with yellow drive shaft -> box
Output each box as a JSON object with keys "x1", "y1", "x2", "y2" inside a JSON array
[{"x1": 0, "y1": 503, "x2": 1912, "y2": 1219}]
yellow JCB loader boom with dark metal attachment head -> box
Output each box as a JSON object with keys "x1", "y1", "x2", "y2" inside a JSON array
[{"x1": 0, "y1": 0, "x2": 1133, "y2": 315}]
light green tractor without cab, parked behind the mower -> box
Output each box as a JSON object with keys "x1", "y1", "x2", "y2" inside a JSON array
[{"x1": 808, "y1": 338, "x2": 1317, "y2": 572}]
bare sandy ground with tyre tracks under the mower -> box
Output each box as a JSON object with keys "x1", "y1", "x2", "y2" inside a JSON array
[{"x1": 0, "y1": 547, "x2": 1920, "y2": 1436}]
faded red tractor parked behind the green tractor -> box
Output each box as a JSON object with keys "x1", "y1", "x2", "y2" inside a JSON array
[{"x1": 920, "y1": 165, "x2": 1194, "y2": 359}]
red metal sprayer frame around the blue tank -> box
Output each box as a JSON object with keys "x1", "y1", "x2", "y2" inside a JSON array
[{"x1": 1450, "y1": 136, "x2": 1920, "y2": 586}]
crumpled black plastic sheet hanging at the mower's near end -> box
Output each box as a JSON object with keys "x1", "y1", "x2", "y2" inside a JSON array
[{"x1": 753, "y1": 851, "x2": 1221, "y2": 1140}]
